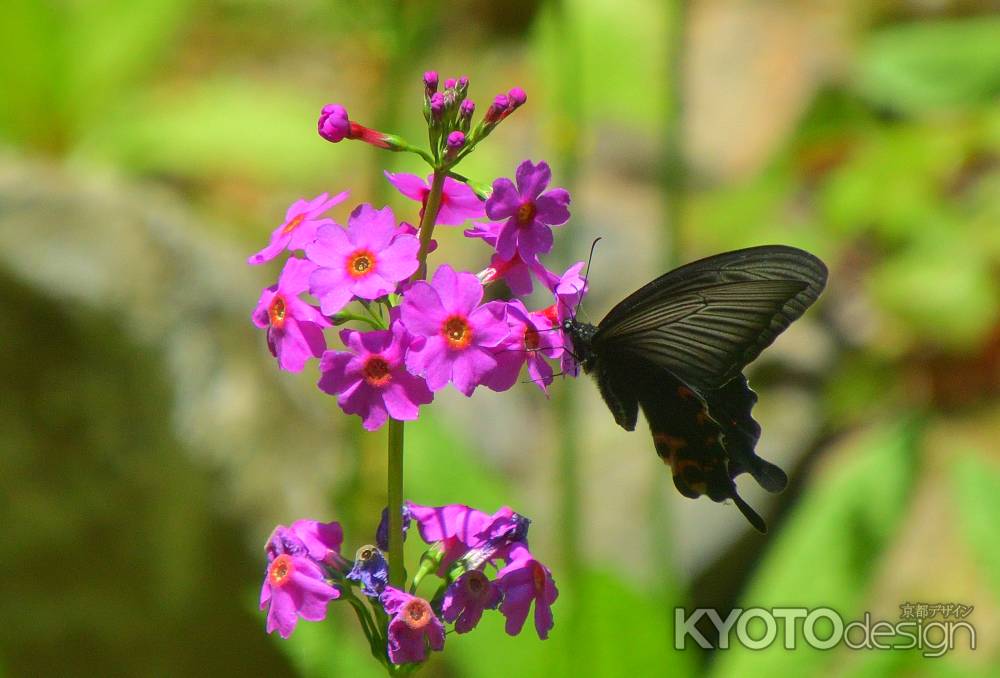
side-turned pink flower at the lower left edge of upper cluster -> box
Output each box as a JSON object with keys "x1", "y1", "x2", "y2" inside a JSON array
[{"x1": 252, "y1": 257, "x2": 330, "y2": 372}]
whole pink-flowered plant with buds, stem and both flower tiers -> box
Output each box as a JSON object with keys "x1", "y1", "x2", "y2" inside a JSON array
[{"x1": 248, "y1": 71, "x2": 586, "y2": 674}]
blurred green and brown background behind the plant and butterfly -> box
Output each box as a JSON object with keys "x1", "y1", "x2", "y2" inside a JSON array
[{"x1": 0, "y1": 0, "x2": 1000, "y2": 677}]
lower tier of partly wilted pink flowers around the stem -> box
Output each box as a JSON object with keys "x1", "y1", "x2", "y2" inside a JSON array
[{"x1": 260, "y1": 502, "x2": 559, "y2": 665}]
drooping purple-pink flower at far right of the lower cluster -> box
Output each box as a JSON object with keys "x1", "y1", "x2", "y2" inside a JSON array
[{"x1": 497, "y1": 545, "x2": 559, "y2": 640}]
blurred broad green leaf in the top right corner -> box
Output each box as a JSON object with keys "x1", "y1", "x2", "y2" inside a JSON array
[{"x1": 857, "y1": 17, "x2": 1000, "y2": 113}]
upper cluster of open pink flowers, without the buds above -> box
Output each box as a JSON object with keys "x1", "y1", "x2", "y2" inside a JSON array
[{"x1": 249, "y1": 161, "x2": 585, "y2": 430}]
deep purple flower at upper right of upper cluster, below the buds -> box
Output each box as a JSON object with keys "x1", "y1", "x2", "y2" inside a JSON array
[{"x1": 486, "y1": 160, "x2": 569, "y2": 260}]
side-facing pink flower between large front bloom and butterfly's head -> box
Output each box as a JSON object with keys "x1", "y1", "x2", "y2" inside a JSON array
[{"x1": 483, "y1": 299, "x2": 562, "y2": 393}]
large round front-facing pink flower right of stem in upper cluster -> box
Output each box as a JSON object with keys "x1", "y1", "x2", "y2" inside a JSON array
[{"x1": 402, "y1": 265, "x2": 508, "y2": 396}]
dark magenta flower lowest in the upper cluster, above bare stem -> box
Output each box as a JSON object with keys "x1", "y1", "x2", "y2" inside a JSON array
[{"x1": 318, "y1": 322, "x2": 434, "y2": 431}]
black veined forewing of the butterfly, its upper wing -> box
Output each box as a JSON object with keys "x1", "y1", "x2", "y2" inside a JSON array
[{"x1": 593, "y1": 245, "x2": 826, "y2": 391}]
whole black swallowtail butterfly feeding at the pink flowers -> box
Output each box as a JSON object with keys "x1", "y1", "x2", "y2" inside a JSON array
[{"x1": 562, "y1": 245, "x2": 827, "y2": 532}]
